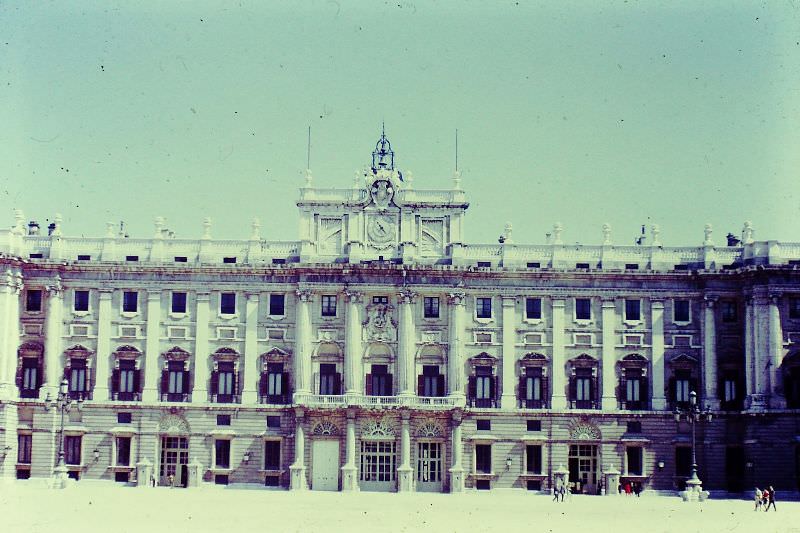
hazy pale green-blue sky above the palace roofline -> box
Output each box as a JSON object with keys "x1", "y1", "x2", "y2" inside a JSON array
[{"x1": 0, "y1": 0, "x2": 800, "y2": 246}]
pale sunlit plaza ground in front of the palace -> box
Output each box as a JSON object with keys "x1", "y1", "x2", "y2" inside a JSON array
[{"x1": 0, "y1": 481, "x2": 800, "y2": 533}]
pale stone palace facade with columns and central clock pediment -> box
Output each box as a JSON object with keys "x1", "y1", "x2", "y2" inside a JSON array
[{"x1": 0, "y1": 136, "x2": 800, "y2": 493}]
